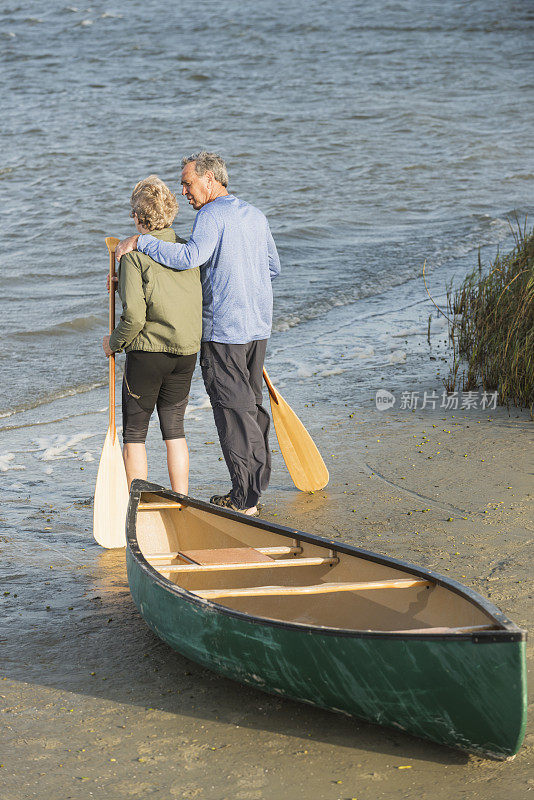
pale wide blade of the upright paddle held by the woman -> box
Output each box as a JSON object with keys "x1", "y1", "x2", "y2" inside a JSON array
[{"x1": 93, "y1": 426, "x2": 128, "y2": 548}]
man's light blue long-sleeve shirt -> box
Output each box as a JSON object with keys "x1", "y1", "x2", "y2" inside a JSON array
[{"x1": 137, "y1": 194, "x2": 280, "y2": 344}]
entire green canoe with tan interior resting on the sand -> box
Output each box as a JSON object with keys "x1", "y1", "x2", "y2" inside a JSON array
[{"x1": 126, "y1": 480, "x2": 526, "y2": 759}]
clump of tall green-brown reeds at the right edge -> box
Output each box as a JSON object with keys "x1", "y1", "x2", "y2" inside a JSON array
[{"x1": 446, "y1": 223, "x2": 534, "y2": 415}]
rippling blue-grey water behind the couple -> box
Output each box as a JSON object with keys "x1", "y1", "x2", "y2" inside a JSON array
[{"x1": 0, "y1": 0, "x2": 534, "y2": 512}]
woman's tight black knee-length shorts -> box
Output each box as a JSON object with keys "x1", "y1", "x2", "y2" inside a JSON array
[{"x1": 122, "y1": 350, "x2": 197, "y2": 444}]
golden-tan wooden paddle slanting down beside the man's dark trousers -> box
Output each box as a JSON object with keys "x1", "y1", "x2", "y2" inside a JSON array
[{"x1": 263, "y1": 369, "x2": 329, "y2": 492}]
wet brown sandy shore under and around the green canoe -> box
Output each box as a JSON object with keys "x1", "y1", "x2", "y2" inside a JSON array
[{"x1": 0, "y1": 405, "x2": 534, "y2": 800}]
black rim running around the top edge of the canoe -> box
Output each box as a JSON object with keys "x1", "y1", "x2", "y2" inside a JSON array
[{"x1": 126, "y1": 479, "x2": 527, "y2": 644}]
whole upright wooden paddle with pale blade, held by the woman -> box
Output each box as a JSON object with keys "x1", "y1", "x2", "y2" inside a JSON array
[{"x1": 93, "y1": 236, "x2": 128, "y2": 548}]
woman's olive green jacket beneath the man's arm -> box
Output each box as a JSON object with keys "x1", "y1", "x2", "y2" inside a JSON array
[{"x1": 109, "y1": 228, "x2": 202, "y2": 356}]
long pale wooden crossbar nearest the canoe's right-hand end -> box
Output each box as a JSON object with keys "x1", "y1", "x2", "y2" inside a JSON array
[{"x1": 195, "y1": 578, "x2": 434, "y2": 600}]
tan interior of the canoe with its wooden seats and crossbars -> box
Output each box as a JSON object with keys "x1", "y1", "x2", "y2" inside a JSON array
[{"x1": 137, "y1": 492, "x2": 503, "y2": 634}]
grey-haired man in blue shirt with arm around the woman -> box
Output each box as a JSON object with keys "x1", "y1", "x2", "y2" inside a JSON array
[{"x1": 117, "y1": 152, "x2": 280, "y2": 516}]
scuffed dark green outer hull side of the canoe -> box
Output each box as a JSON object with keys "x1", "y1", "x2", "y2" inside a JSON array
[{"x1": 126, "y1": 547, "x2": 526, "y2": 759}]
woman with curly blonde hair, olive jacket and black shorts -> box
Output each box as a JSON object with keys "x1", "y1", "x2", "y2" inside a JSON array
[{"x1": 103, "y1": 175, "x2": 202, "y2": 494}]
